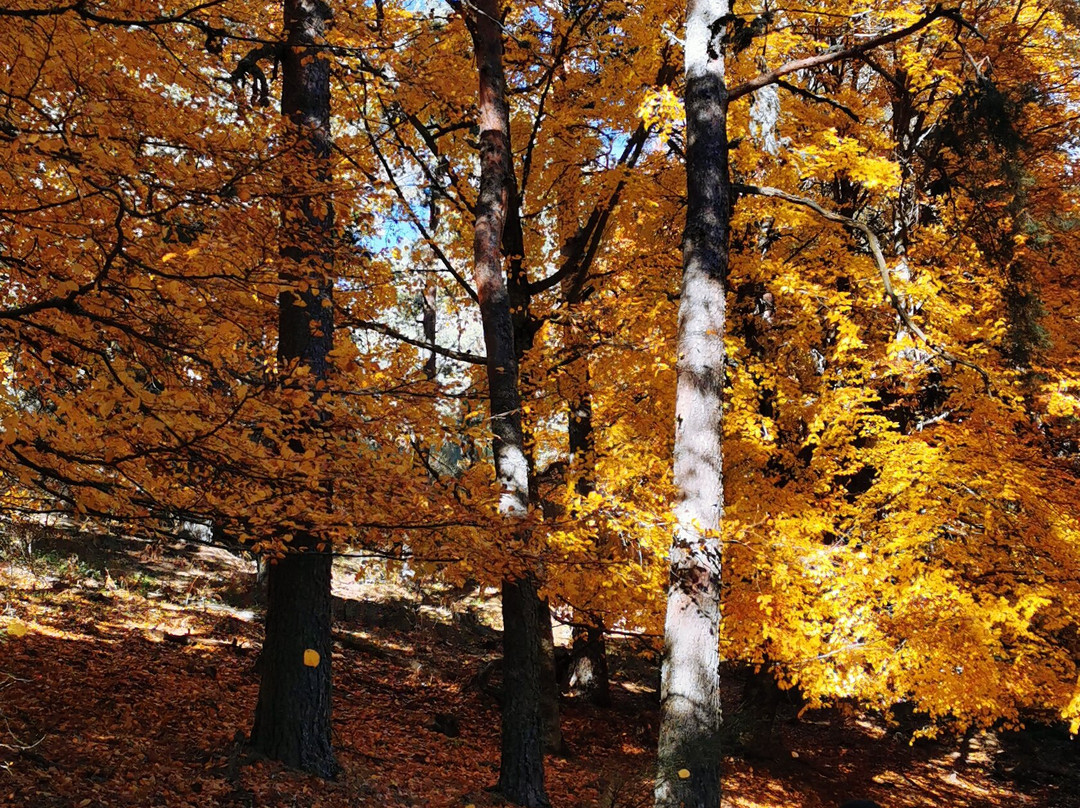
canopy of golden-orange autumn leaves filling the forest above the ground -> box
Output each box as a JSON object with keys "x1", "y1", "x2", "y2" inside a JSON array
[{"x1": 6, "y1": 0, "x2": 1080, "y2": 724}]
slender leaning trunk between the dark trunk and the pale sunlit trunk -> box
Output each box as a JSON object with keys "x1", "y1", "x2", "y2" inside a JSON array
[{"x1": 460, "y1": 0, "x2": 548, "y2": 808}]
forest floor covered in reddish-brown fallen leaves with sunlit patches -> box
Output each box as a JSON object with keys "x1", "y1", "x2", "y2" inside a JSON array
[{"x1": 0, "y1": 529, "x2": 1080, "y2": 808}]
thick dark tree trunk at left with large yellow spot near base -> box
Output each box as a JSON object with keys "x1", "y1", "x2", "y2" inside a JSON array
[{"x1": 251, "y1": 0, "x2": 337, "y2": 777}]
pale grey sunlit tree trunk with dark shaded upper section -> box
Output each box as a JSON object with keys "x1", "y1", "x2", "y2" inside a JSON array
[{"x1": 656, "y1": 0, "x2": 731, "y2": 808}]
